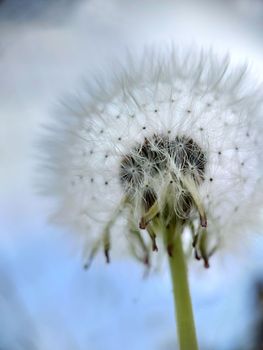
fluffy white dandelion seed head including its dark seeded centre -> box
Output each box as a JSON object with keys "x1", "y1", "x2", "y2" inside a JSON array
[{"x1": 39, "y1": 51, "x2": 263, "y2": 349}]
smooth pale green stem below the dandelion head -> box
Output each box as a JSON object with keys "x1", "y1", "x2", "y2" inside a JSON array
[{"x1": 166, "y1": 223, "x2": 198, "y2": 350}]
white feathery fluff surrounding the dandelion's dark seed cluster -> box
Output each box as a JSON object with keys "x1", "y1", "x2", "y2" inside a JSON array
[{"x1": 38, "y1": 50, "x2": 263, "y2": 262}]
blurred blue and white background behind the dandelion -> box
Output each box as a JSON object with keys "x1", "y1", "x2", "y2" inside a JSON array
[{"x1": 0, "y1": 0, "x2": 263, "y2": 350}]
